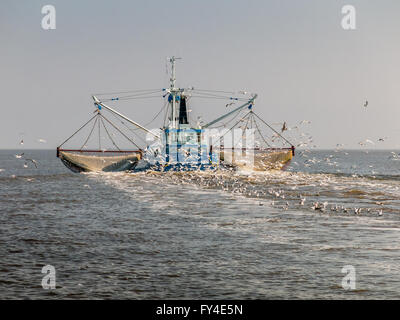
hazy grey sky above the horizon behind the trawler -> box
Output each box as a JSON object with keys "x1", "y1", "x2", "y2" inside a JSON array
[{"x1": 0, "y1": 0, "x2": 400, "y2": 148}]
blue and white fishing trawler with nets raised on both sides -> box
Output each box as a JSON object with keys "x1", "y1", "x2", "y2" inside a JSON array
[{"x1": 57, "y1": 57, "x2": 295, "y2": 172}]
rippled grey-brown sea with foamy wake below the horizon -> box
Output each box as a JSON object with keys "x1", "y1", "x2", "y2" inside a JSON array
[{"x1": 0, "y1": 150, "x2": 400, "y2": 299}]
